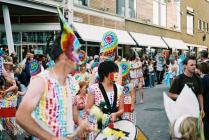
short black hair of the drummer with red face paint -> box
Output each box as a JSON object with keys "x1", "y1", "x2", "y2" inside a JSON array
[{"x1": 98, "y1": 61, "x2": 119, "y2": 82}]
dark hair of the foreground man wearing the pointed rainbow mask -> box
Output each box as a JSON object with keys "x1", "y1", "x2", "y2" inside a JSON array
[{"x1": 47, "y1": 33, "x2": 62, "y2": 61}]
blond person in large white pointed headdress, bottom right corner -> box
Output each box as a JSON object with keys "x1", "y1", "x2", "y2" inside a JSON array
[{"x1": 164, "y1": 85, "x2": 204, "y2": 140}]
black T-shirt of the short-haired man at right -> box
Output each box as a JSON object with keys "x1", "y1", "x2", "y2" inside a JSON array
[{"x1": 169, "y1": 74, "x2": 203, "y2": 96}]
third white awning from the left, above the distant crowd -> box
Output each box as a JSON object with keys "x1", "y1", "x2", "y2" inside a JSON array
[{"x1": 163, "y1": 37, "x2": 188, "y2": 50}]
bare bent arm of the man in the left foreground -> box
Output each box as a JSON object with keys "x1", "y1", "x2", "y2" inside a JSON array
[{"x1": 16, "y1": 77, "x2": 53, "y2": 140}]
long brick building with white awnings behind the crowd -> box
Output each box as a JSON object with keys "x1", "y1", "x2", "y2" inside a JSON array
[{"x1": 0, "y1": 0, "x2": 209, "y2": 59}]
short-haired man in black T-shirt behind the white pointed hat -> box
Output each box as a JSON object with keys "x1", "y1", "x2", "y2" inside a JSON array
[{"x1": 169, "y1": 56, "x2": 204, "y2": 117}]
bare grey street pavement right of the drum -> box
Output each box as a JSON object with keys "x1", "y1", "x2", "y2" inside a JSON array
[{"x1": 135, "y1": 84, "x2": 169, "y2": 140}]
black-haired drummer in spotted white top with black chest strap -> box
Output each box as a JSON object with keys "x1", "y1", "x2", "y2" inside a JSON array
[{"x1": 86, "y1": 61, "x2": 124, "y2": 140}]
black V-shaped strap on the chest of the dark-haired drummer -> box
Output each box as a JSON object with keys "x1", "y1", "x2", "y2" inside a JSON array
[{"x1": 99, "y1": 83, "x2": 117, "y2": 114}]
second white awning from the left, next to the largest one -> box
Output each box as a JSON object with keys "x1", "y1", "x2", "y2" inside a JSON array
[{"x1": 130, "y1": 32, "x2": 168, "y2": 49}]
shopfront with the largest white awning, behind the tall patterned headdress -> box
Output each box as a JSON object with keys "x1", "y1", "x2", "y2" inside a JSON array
[{"x1": 73, "y1": 23, "x2": 136, "y2": 57}]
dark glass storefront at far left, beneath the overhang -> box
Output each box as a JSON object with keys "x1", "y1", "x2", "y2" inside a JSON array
[{"x1": 0, "y1": 31, "x2": 56, "y2": 60}]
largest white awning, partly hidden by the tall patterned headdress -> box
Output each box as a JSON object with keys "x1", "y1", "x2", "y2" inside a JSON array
[{"x1": 73, "y1": 22, "x2": 136, "y2": 45}]
